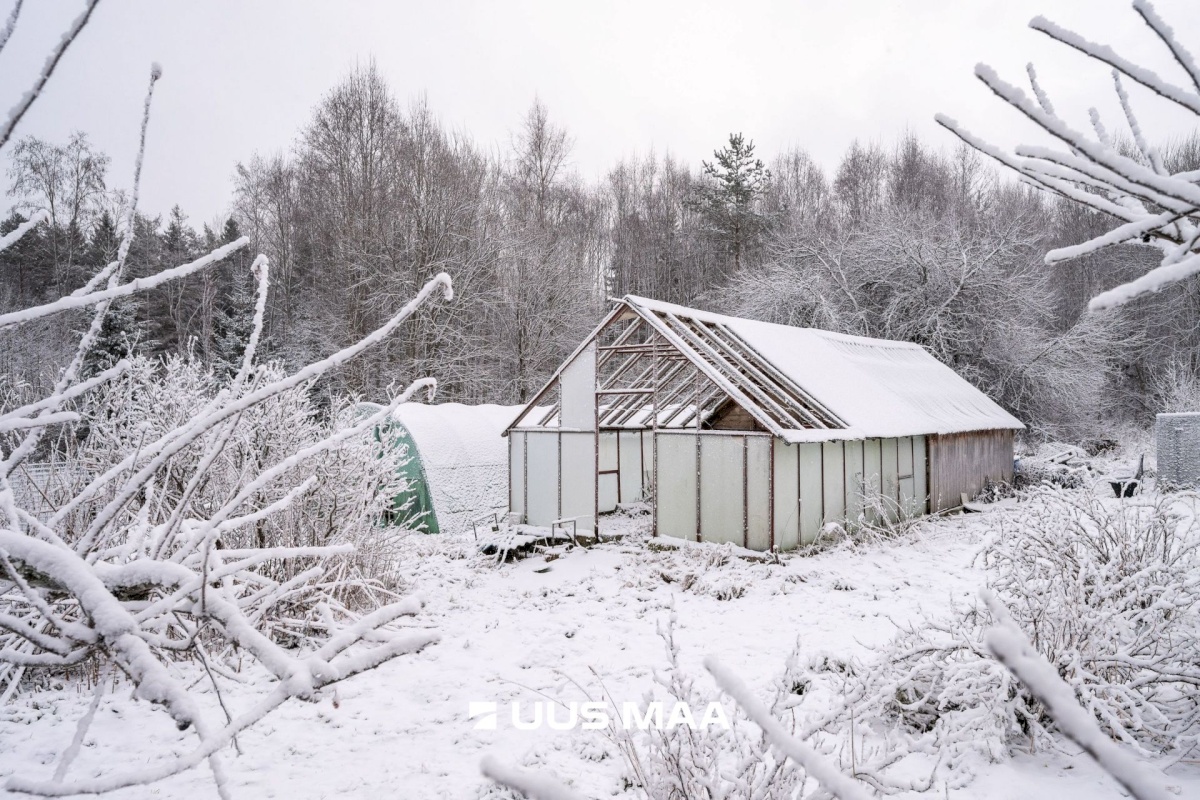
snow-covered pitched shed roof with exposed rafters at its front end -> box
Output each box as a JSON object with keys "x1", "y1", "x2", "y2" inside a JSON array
[{"x1": 506, "y1": 295, "x2": 1025, "y2": 441}]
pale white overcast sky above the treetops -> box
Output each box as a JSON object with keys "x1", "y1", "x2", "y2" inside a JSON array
[{"x1": 0, "y1": 0, "x2": 1200, "y2": 225}]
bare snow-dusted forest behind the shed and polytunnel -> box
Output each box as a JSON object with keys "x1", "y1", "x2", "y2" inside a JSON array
[{"x1": 0, "y1": 65, "x2": 1200, "y2": 440}]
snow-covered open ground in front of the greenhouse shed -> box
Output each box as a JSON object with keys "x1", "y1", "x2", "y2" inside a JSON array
[{"x1": 0, "y1": 503, "x2": 1200, "y2": 800}]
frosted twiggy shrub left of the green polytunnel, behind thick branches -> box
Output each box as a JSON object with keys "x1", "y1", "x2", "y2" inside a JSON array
[{"x1": 47, "y1": 356, "x2": 403, "y2": 623}]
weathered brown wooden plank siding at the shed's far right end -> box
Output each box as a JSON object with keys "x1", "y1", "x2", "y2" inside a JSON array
[{"x1": 928, "y1": 431, "x2": 1013, "y2": 512}]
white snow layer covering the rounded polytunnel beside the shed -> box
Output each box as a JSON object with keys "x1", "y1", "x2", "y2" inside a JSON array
[{"x1": 394, "y1": 403, "x2": 532, "y2": 534}]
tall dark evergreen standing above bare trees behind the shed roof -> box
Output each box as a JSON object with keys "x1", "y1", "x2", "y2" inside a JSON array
[{"x1": 689, "y1": 133, "x2": 770, "y2": 272}]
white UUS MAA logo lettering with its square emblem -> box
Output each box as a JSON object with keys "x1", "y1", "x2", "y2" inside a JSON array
[{"x1": 467, "y1": 700, "x2": 730, "y2": 730}]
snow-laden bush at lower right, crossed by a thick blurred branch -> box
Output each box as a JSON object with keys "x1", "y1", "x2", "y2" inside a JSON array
[{"x1": 810, "y1": 488, "x2": 1200, "y2": 789}]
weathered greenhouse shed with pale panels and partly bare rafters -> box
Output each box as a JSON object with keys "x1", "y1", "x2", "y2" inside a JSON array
[{"x1": 505, "y1": 295, "x2": 1024, "y2": 551}]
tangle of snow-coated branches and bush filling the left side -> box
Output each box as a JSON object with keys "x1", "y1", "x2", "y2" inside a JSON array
[{"x1": 0, "y1": 14, "x2": 452, "y2": 798}]
